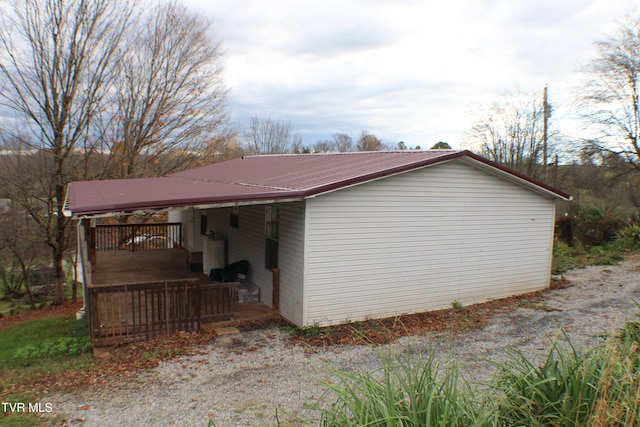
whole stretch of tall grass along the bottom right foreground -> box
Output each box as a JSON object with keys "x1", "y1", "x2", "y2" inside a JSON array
[{"x1": 303, "y1": 321, "x2": 640, "y2": 427}]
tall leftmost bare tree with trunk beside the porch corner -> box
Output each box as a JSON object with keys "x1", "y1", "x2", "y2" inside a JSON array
[{"x1": 0, "y1": 0, "x2": 133, "y2": 303}]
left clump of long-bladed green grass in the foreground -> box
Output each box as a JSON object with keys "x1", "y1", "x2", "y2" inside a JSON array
[{"x1": 308, "y1": 352, "x2": 483, "y2": 427}]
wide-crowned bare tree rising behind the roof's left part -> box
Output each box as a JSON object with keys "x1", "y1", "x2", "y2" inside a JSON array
[{"x1": 102, "y1": 2, "x2": 227, "y2": 178}]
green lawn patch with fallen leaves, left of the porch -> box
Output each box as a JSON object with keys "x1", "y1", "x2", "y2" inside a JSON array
[{"x1": 0, "y1": 316, "x2": 92, "y2": 427}]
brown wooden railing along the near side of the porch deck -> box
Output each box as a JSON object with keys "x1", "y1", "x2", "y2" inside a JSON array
[{"x1": 88, "y1": 278, "x2": 238, "y2": 346}]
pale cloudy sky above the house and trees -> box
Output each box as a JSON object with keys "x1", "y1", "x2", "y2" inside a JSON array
[{"x1": 185, "y1": 0, "x2": 638, "y2": 148}]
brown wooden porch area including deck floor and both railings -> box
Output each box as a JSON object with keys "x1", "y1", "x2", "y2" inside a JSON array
[{"x1": 79, "y1": 220, "x2": 279, "y2": 346}]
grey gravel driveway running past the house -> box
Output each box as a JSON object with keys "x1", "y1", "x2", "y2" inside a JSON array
[{"x1": 47, "y1": 256, "x2": 640, "y2": 427}]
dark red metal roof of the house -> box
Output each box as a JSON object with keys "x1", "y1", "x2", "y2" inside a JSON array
[{"x1": 67, "y1": 150, "x2": 569, "y2": 216}]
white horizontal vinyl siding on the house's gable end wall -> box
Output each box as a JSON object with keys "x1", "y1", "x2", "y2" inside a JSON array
[{"x1": 303, "y1": 161, "x2": 555, "y2": 325}]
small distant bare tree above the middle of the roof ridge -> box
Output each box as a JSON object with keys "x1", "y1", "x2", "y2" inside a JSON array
[{"x1": 244, "y1": 116, "x2": 302, "y2": 154}]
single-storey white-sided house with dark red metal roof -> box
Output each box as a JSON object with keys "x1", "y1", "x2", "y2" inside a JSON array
[{"x1": 67, "y1": 150, "x2": 570, "y2": 344}]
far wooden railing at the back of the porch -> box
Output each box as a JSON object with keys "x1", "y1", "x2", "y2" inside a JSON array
[{"x1": 92, "y1": 222, "x2": 182, "y2": 251}]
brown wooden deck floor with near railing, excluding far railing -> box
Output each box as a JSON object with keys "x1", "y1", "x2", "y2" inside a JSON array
[{"x1": 88, "y1": 248, "x2": 279, "y2": 346}]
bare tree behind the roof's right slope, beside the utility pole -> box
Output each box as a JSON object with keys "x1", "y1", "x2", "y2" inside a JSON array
[{"x1": 465, "y1": 93, "x2": 556, "y2": 177}]
